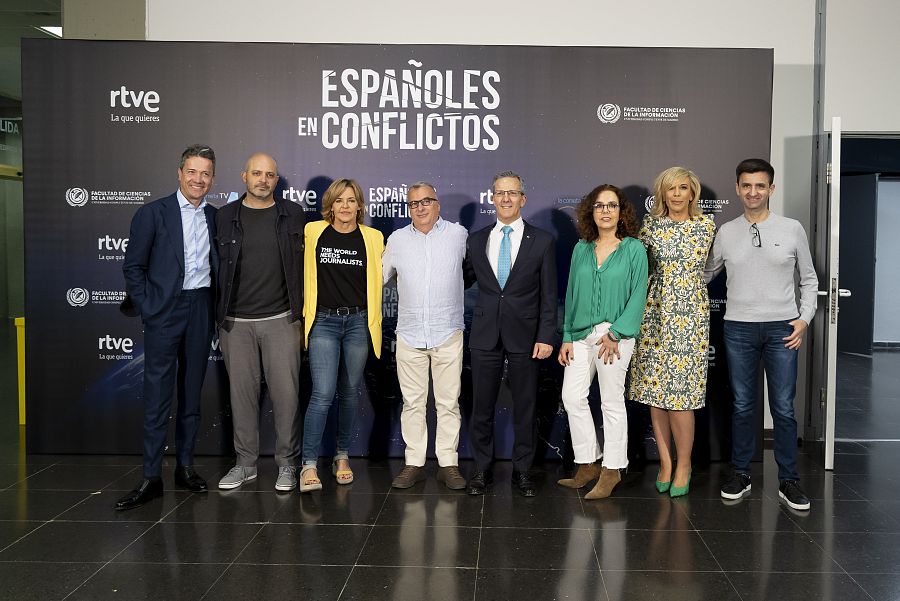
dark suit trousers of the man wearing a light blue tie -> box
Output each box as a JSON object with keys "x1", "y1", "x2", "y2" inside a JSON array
[{"x1": 469, "y1": 342, "x2": 538, "y2": 472}]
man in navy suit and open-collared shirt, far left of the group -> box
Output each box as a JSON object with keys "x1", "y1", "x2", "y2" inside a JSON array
[{"x1": 116, "y1": 145, "x2": 218, "y2": 510}]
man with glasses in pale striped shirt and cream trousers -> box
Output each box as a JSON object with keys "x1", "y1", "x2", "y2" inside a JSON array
[{"x1": 382, "y1": 182, "x2": 468, "y2": 490}]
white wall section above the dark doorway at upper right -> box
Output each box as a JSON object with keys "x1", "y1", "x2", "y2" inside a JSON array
[{"x1": 823, "y1": 0, "x2": 900, "y2": 132}]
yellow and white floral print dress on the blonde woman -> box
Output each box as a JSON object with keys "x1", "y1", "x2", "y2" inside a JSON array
[{"x1": 630, "y1": 215, "x2": 715, "y2": 411}]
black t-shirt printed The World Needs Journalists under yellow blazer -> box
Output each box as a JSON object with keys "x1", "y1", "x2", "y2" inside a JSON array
[{"x1": 316, "y1": 226, "x2": 366, "y2": 309}]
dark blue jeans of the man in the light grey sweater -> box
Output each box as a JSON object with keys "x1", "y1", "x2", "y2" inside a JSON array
[{"x1": 724, "y1": 320, "x2": 799, "y2": 480}]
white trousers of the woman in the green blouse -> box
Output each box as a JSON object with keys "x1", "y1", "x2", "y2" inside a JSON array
[{"x1": 562, "y1": 322, "x2": 634, "y2": 469}]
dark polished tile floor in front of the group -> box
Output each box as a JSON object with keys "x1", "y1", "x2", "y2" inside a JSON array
[{"x1": 0, "y1": 437, "x2": 900, "y2": 601}]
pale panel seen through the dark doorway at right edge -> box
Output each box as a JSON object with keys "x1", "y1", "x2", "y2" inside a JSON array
[{"x1": 874, "y1": 180, "x2": 900, "y2": 343}]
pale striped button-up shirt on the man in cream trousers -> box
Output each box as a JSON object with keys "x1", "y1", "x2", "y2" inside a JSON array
[{"x1": 382, "y1": 218, "x2": 468, "y2": 349}]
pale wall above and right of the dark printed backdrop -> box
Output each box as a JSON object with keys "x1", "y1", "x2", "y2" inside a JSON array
[{"x1": 147, "y1": 0, "x2": 816, "y2": 225}]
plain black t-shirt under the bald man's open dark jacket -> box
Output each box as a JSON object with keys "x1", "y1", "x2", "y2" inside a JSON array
[{"x1": 228, "y1": 205, "x2": 290, "y2": 319}]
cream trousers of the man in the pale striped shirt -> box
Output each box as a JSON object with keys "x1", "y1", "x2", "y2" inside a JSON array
[{"x1": 397, "y1": 330, "x2": 463, "y2": 467}]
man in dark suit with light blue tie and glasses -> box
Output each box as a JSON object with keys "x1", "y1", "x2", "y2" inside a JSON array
[{"x1": 466, "y1": 171, "x2": 557, "y2": 497}]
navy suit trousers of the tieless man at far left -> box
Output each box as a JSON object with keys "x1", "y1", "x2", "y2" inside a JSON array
[{"x1": 144, "y1": 288, "x2": 213, "y2": 478}]
